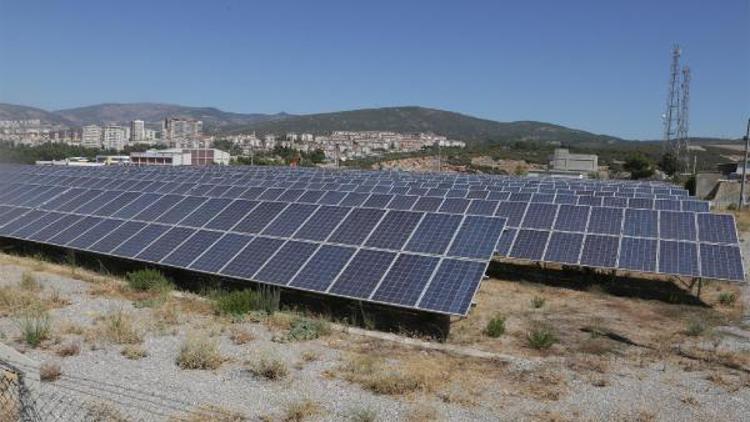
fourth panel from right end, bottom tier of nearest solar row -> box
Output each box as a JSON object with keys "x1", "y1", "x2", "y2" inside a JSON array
[{"x1": 290, "y1": 245, "x2": 356, "y2": 292}]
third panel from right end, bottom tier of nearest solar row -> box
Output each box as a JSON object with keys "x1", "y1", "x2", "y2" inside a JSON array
[{"x1": 329, "y1": 249, "x2": 396, "y2": 299}]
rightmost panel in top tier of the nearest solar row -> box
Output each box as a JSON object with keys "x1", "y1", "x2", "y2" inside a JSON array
[{"x1": 447, "y1": 215, "x2": 505, "y2": 260}]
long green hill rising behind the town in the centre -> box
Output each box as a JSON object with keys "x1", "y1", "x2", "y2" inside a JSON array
[{"x1": 228, "y1": 107, "x2": 621, "y2": 145}]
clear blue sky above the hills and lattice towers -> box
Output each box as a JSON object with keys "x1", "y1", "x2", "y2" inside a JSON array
[{"x1": 0, "y1": 0, "x2": 750, "y2": 139}]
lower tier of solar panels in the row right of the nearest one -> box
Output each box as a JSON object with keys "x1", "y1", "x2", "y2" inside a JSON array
[{"x1": 498, "y1": 229, "x2": 744, "y2": 281}]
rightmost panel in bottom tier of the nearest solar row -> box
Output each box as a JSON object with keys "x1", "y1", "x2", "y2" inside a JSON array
[{"x1": 417, "y1": 259, "x2": 486, "y2": 315}]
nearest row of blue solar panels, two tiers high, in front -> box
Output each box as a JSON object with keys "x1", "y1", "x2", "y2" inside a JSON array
[{"x1": 0, "y1": 200, "x2": 504, "y2": 315}]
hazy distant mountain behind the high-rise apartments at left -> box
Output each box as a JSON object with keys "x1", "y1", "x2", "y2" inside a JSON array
[{"x1": 54, "y1": 103, "x2": 287, "y2": 131}]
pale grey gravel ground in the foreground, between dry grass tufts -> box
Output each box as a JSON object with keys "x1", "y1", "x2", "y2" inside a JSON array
[{"x1": 0, "y1": 258, "x2": 750, "y2": 421}]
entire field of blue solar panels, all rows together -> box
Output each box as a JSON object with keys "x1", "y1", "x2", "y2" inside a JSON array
[{"x1": 0, "y1": 166, "x2": 744, "y2": 314}]
